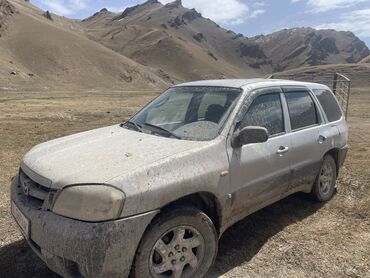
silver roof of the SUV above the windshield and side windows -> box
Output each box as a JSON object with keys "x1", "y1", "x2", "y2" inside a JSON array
[{"x1": 175, "y1": 78, "x2": 328, "y2": 89}]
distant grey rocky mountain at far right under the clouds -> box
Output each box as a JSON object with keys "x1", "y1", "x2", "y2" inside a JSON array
[{"x1": 252, "y1": 28, "x2": 370, "y2": 71}]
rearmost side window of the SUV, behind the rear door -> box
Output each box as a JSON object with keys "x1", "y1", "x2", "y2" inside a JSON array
[{"x1": 313, "y1": 89, "x2": 342, "y2": 122}]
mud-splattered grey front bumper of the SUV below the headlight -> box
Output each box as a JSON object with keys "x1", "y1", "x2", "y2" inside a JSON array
[{"x1": 11, "y1": 178, "x2": 158, "y2": 277}]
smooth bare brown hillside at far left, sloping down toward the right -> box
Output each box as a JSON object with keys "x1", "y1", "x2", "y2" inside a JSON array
[{"x1": 0, "y1": 0, "x2": 167, "y2": 89}]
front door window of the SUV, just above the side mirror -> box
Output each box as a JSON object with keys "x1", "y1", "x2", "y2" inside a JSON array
[{"x1": 239, "y1": 93, "x2": 285, "y2": 135}]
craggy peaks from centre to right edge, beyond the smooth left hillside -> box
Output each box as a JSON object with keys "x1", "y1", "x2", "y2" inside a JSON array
[{"x1": 82, "y1": 0, "x2": 370, "y2": 80}]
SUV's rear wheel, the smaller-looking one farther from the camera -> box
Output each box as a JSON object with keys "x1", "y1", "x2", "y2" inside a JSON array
[{"x1": 312, "y1": 155, "x2": 337, "y2": 202}]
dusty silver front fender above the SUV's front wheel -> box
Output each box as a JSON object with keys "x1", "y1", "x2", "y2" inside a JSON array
[{"x1": 107, "y1": 139, "x2": 230, "y2": 225}]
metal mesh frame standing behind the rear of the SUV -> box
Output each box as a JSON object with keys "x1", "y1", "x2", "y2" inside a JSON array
[{"x1": 268, "y1": 72, "x2": 351, "y2": 119}]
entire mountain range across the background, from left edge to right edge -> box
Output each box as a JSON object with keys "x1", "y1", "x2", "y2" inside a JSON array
[{"x1": 0, "y1": 0, "x2": 370, "y2": 89}]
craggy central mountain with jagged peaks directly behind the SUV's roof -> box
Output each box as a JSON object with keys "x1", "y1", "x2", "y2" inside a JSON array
[{"x1": 82, "y1": 0, "x2": 273, "y2": 82}]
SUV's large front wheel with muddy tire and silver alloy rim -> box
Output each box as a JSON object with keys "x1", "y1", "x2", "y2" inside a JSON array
[{"x1": 131, "y1": 208, "x2": 218, "y2": 278}]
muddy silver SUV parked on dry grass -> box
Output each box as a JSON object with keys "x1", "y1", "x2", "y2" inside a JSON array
[{"x1": 11, "y1": 79, "x2": 347, "y2": 278}]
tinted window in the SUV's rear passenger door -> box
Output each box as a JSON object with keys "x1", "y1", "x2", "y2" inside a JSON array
[{"x1": 285, "y1": 91, "x2": 319, "y2": 130}]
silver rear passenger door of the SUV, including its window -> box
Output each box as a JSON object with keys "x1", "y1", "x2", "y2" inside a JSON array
[{"x1": 283, "y1": 87, "x2": 324, "y2": 190}]
